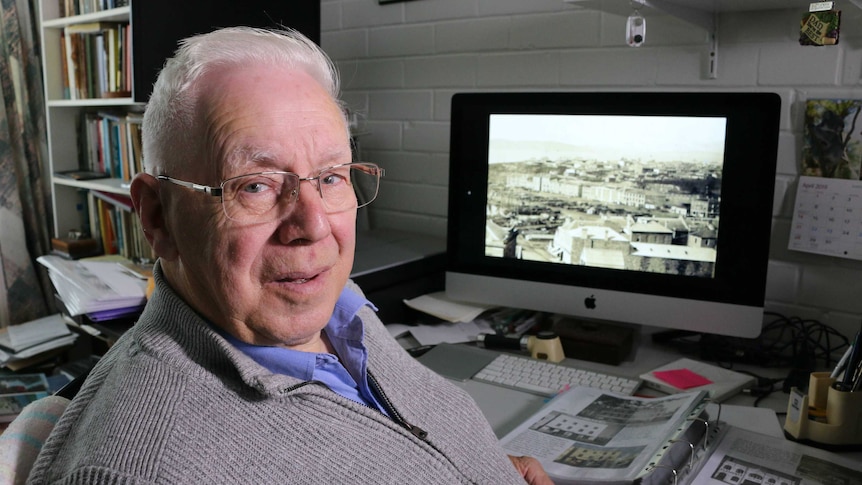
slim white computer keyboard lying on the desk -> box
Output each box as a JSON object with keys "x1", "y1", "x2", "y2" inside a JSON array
[{"x1": 473, "y1": 354, "x2": 641, "y2": 396}]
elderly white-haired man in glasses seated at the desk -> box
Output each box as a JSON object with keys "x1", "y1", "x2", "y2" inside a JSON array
[{"x1": 31, "y1": 28, "x2": 549, "y2": 484}]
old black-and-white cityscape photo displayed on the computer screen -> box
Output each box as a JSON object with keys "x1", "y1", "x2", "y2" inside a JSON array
[{"x1": 485, "y1": 114, "x2": 727, "y2": 278}]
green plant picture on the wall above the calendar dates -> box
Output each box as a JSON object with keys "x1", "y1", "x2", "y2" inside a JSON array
[{"x1": 802, "y1": 99, "x2": 862, "y2": 180}]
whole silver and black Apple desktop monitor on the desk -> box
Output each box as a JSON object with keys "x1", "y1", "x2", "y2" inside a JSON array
[{"x1": 446, "y1": 92, "x2": 780, "y2": 338}]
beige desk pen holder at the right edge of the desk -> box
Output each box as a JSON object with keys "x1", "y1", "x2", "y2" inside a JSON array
[{"x1": 784, "y1": 372, "x2": 862, "y2": 446}]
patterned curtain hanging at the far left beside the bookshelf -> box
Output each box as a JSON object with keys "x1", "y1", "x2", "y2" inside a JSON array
[{"x1": 0, "y1": 0, "x2": 56, "y2": 327}]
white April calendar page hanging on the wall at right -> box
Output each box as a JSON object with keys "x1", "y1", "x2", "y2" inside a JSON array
[{"x1": 789, "y1": 176, "x2": 862, "y2": 260}]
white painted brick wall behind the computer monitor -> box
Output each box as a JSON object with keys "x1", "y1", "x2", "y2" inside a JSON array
[{"x1": 321, "y1": 0, "x2": 862, "y2": 336}]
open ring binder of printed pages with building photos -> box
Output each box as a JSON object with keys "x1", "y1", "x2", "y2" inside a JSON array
[{"x1": 500, "y1": 387, "x2": 862, "y2": 485}]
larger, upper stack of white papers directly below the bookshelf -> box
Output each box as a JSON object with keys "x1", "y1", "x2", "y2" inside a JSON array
[{"x1": 37, "y1": 256, "x2": 147, "y2": 316}]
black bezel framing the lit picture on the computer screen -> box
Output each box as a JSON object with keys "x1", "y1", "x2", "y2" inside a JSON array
[{"x1": 447, "y1": 92, "x2": 780, "y2": 307}]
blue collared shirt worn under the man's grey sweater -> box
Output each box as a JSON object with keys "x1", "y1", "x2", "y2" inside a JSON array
[{"x1": 220, "y1": 288, "x2": 386, "y2": 413}]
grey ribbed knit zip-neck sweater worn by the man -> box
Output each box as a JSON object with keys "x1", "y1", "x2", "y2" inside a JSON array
[{"x1": 28, "y1": 264, "x2": 524, "y2": 485}]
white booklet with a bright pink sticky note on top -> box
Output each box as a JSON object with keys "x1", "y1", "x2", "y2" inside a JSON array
[{"x1": 640, "y1": 358, "x2": 756, "y2": 402}]
